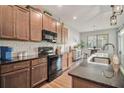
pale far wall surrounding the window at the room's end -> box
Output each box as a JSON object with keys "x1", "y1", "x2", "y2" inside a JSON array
[{"x1": 80, "y1": 29, "x2": 118, "y2": 52}]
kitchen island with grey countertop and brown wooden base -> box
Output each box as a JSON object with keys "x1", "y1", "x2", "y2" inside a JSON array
[{"x1": 68, "y1": 59, "x2": 124, "y2": 88}]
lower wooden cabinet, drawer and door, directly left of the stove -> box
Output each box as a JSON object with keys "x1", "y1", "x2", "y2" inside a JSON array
[{"x1": 31, "y1": 59, "x2": 47, "y2": 87}]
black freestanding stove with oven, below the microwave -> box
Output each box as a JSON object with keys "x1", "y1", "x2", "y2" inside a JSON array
[{"x1": 38, "y1": 47, "x2": 62, "y2": 81}]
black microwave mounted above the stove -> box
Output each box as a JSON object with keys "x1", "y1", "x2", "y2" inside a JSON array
[{"x1": 42, "y1": 30, "x2": 57, "y2": 43}]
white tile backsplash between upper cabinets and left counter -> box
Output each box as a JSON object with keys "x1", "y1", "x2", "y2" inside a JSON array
[{"x1": 0, "y1": 40, "x2": 64, "y2": 57}]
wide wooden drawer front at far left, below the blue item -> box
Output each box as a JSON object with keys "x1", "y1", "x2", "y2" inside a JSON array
[{"x1": 1, "y1": 61, "x2": 30, "y2": 73}]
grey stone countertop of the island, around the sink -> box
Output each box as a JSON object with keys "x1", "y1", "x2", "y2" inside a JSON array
[{"x1": 68, "y1": 60, "x2": 124, "y2": 88}]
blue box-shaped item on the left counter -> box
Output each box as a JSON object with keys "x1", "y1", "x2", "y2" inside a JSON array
[{"x1": 0, "y1": 46, "x2": 13, "y2": 61}]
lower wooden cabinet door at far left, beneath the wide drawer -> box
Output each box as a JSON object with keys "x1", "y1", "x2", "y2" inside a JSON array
[{"x1": 1, "y1": 68, "x2": 30, "y2": 88}]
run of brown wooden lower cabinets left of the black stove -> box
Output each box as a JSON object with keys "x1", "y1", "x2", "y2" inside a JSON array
[{"x1": 0, "y1": 57, "x2": 47, "y2": 88}]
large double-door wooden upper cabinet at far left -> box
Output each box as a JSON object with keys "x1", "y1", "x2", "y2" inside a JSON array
[{"x1": 0, "y1": 5, "x2": 29, "y2": 40}]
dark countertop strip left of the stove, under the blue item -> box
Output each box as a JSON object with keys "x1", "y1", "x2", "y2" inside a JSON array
[{"x1": 0, "y1": 55, "x2": 45, "y2": 65}]
